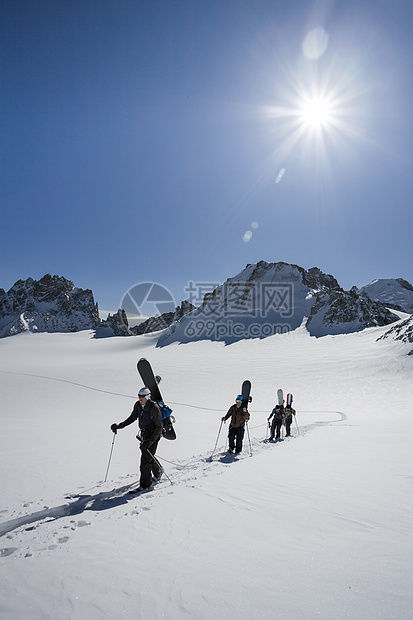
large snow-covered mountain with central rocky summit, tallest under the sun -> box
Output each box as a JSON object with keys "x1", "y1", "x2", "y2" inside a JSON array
[{"x1": 158, "y1": 261, "x2": 399, "y2": 346}]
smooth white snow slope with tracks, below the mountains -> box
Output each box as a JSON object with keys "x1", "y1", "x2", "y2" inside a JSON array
[{"x1": 0, "y1": 327, "x2": 413, "y2": 620}]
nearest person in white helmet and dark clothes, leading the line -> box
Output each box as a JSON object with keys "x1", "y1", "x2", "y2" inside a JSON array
[{"x1": 110, "y1": 387, "x2": 163, "y2": 491}]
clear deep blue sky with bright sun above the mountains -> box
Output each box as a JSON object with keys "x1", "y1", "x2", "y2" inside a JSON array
[{"x1": 0, "y1": 0, "x2": 413, "y2": 310}]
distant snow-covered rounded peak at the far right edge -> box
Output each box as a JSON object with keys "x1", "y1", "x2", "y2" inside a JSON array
[{"x1": 352, "y1": 278, "x2": 413, "y2": 314}]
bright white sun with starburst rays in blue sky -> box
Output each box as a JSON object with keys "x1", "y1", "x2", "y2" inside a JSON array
[{"x1": 260, "y1": 47, "x2": 369, "y2": 172}]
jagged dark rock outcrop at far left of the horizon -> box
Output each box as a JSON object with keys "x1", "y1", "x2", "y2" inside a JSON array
[{"x1": 0, "y1": 274, "x2": 99, "y2": 337}]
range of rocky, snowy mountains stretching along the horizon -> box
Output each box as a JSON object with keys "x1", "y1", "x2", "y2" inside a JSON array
[{"x1": 0, "y1": 261, "x2": 413, "y2": 346}]
